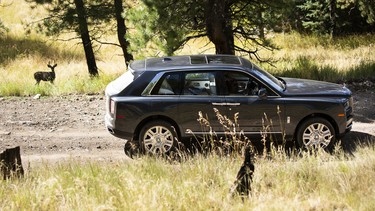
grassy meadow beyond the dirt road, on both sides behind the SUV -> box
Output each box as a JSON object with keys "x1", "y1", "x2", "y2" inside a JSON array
[{"x1": 0, "y1": 30, "x2": 375, "y2": 96}]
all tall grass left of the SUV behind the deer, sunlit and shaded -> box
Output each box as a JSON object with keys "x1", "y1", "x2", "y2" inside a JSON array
[{"x1": 0, "y1": 0, "x2": 126, "y2": 96}]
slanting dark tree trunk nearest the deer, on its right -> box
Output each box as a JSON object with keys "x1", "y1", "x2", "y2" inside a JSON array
[{"x1": 74, "y1": 0, "x2": 99, "y2": 76}]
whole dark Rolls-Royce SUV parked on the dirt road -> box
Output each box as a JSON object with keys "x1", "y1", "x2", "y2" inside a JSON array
[{"x1": 105, "y1": 55, "x2": 353, "y2": 153}]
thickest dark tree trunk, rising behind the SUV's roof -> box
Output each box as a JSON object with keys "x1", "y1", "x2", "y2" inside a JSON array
[{"x1": 205, "y1": 0, "x2": 235, "y2": 55}]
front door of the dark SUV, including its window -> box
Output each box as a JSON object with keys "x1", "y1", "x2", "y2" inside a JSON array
[{"x1": 221, "y1": 71, "x2": 283, "y2": 140}]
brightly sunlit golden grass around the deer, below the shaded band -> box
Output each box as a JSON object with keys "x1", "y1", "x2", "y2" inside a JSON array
[{"x1": 0, "y1": 53, "x2": 125, "y2": 96}]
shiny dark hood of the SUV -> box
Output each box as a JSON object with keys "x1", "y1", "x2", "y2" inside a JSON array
[{"x1": 282, "y1": 78, "x2": 352, "y2": 96}]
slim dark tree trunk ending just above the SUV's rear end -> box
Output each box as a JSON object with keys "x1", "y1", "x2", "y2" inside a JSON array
[{"x1": 115, "y1": 0, "x2": 133, "y2": 66}]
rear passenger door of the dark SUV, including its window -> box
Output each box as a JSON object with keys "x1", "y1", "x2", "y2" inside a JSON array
[{"x1": 178, "y1": 71, "x2": 227, "y2": 136}]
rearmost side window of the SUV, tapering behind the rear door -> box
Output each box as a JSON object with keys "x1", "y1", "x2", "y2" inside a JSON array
[{"x1": 151, "y1": 73, "x2": 181, "y2": 95}]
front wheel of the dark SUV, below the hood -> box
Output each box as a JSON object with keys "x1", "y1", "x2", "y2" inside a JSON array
[{"x1": 297, "y1": 117, "x2": 336, "y2": 151}]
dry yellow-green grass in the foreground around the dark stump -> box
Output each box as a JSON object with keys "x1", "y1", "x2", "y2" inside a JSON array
[{"x1": 0, "y1": 147, "x2": 375, "y2": 210}]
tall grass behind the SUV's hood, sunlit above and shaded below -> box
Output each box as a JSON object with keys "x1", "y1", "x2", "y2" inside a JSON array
[{"x1": 262, "y1": 33, "x2": 375, "y2": 82}]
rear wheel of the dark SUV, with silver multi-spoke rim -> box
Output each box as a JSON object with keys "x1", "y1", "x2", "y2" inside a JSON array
[{"x1": 139, "y1": 120, "x2": 178, "y2": 155}]
